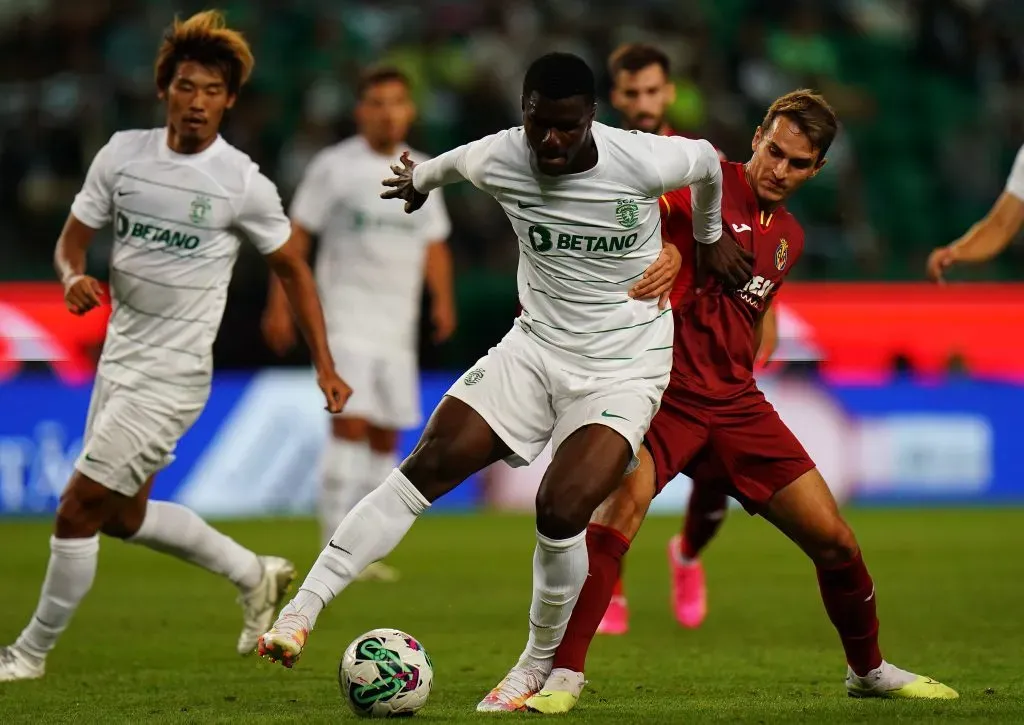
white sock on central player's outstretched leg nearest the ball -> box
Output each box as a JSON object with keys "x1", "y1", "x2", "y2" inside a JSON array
[{"x1": 283, "y1": 468, "x2": 428, "y2": 627}]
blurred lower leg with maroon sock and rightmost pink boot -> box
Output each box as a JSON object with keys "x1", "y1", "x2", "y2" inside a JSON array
[{"x1": 668, "y1": 479, "x2": 729, "y2": 629}]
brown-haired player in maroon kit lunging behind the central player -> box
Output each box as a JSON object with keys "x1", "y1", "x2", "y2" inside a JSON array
[{"x1": 525, "y1": 90, "x2": 957, "y2": 714}]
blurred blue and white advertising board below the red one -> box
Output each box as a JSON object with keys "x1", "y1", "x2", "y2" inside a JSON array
[{"x1": 0, "y1": 370, "x2": 1024, "y2": 517}]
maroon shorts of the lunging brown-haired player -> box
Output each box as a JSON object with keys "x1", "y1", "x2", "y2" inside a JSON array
[{"x1": 644, "y1": 389, "x2": 814, "y2": 513}]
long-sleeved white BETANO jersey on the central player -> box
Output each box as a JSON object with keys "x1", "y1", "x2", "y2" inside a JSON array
[{"x1": 411, "y1": 123, "x2": 722, "y2": 376}]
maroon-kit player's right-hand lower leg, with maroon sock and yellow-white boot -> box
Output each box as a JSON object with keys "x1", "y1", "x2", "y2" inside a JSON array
[{"x1": 762, "y1": 469, "x2": 957, "y2": 699}]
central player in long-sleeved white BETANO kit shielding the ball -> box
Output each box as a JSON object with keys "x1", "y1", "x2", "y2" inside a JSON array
[{"x1": 259, "y1": 53, "x2": 751, "y2": 696}]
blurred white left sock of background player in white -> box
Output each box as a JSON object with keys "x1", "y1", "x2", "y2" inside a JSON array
[{"x1": 316, "y1": 436, "x2": 372, "y2": 546}]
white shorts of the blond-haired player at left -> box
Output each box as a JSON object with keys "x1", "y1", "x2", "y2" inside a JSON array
[{"x1": 75, "y1": 376, "x2": 208, "y2": 497}]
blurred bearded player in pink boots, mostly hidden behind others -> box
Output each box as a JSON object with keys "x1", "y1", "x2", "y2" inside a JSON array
[{"x1": 597, "y1": 43, "x2": 776, "y2": 635}]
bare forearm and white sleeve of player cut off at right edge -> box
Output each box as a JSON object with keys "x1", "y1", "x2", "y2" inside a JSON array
[{"x1": 926, "y1": 145, "x2": 1024, "y2": 284}]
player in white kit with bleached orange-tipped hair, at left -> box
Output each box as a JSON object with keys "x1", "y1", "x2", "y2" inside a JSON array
[{"x1": 0, "y1": 11, "x2": 349, "y2": 681}]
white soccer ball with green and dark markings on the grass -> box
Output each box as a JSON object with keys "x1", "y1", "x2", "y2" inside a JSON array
[{"x1": 338, "y1": 629, "x2": 434, "y2": 718}]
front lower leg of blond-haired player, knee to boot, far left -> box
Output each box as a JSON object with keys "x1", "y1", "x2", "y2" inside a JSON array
[{"x1": 0, "y1": 471, "x2": 113, "y2": 682}]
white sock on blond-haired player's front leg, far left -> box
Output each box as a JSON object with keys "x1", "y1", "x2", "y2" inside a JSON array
[{"x1": 14, "y1": 536, "x2": 99, "y2": 660}]
